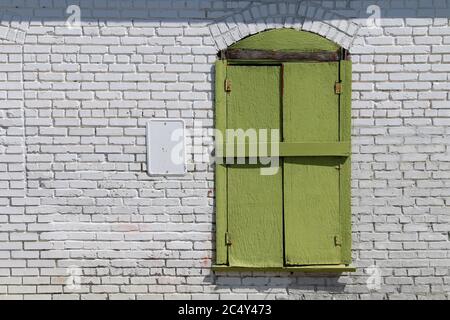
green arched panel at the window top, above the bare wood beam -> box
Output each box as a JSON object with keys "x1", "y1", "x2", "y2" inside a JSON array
[{"x1": 229, "y1": 29, "x2": 339, "y2": 52}]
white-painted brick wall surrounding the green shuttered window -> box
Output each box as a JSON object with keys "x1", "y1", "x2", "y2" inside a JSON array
[{"x1": 0, "y1": 0, "x2": 450, "y2": 299}]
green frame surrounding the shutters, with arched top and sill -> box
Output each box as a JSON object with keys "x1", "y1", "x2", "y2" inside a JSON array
[{"x1": 213, "y1": 29, "x2": 356, "y2": 273}]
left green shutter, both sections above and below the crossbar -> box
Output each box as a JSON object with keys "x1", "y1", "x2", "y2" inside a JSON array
[{"x1": 227, "y1": 66, "x2": 283, "y2": 267}]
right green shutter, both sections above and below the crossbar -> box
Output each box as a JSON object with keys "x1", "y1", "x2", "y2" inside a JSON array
[{"x1": 283, "y1": 62, "x2": 343, "y2": 265}]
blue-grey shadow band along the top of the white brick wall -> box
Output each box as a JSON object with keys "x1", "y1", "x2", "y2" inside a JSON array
[{"x1": 0, "y1": 0, "x2": 444, "y2": 43}]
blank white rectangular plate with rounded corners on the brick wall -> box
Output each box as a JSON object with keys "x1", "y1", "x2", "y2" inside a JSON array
[{"x1": 147, "y1": 119, "x2": 186, "y2": 175}]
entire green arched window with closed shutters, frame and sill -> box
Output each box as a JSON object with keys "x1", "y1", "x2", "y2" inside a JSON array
[{"x1": 214, "y1": 29, "x2": 354, "y2": 272}]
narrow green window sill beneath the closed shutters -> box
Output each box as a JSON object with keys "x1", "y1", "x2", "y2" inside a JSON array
[{"x1": 212, "y1": 264, "x2": 356, "y2": 273}]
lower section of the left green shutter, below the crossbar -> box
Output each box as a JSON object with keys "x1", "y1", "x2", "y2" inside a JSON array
[{"x1": 228, "y1": 165, "x2": 283, "y2": 267}]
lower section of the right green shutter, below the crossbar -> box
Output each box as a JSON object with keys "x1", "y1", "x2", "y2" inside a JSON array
[{"x1": 284, "y1": 157, "x2": 341, "y2": 265}]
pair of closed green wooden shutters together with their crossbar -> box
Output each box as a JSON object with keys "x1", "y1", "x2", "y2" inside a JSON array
[{"x1": 216, "y1": 61, "x2": 351, "y2": 267}]
